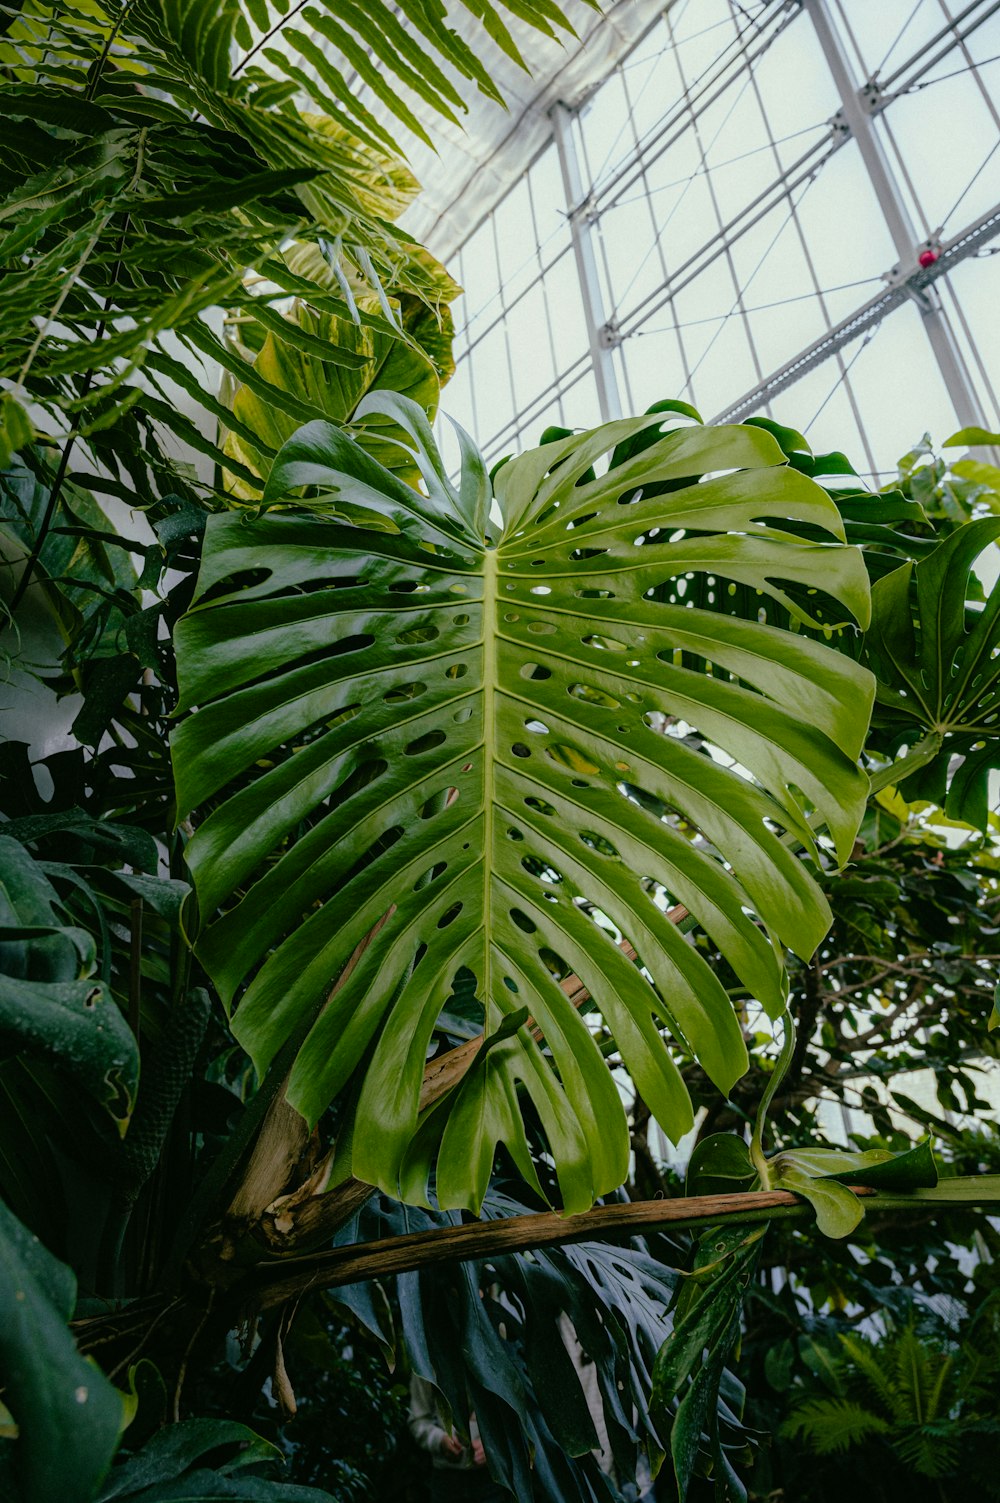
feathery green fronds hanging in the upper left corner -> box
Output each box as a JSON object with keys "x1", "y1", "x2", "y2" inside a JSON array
[{"x1": 0, "y1": 0, "x2": 559, "y2": 494}]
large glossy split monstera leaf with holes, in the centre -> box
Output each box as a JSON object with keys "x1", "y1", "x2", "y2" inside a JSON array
[{"x1": 173, "y1": 394, "x2": 872, "y2": 1211}]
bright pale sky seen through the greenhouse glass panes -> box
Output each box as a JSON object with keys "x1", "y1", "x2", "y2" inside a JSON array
[{"x1": 441, "y1": 0, "x2": 1000, "y2": 472}]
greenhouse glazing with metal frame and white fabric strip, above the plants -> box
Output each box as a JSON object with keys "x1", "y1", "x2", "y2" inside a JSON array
[{"x1": 341, "y1": 0, "x2": 1000, "y2": 481}]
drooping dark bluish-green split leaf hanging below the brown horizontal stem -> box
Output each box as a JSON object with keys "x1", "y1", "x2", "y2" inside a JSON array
[{"x1": 338, "y1": 1190, "x2": 677, "y2": 1503}]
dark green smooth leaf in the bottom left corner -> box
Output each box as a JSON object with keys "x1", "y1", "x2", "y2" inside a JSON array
[{"x1": 0, "y1": 1201, "x2": 126, "y2": 1503}]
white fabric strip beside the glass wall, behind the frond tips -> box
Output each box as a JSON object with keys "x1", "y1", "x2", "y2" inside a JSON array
[{"x1": 372, "y1": 0, "x2": 666, "y2": 265}]
